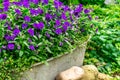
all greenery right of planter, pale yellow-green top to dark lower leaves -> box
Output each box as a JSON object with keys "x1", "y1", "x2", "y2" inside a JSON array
[{"x1": 84, "y1": 4, "x2": 120, "y2": 80}]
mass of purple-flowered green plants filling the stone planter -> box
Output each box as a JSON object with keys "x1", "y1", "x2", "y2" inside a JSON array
[{"x1": 0, "y1": 0, "x2": 98, "y2": 80}]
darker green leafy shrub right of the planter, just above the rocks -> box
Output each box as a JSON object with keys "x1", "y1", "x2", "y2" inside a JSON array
[{"x1": 86, "y1": 29, "x2": 120, "y2": 74}]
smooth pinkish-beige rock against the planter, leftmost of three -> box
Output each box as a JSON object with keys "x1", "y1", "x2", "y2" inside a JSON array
[{"x1": 56, "y1": 66, "x2": 84, "y2": 80}]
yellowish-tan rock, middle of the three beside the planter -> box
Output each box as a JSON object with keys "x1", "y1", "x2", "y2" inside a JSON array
[{"x1": 80, "y1": 65, "x2": 98, "y2": 80}]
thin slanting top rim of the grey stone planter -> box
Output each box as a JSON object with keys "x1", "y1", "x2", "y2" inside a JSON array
[{"x1": 31, "y1": 35, "x2": 92, "y2": 68}]
